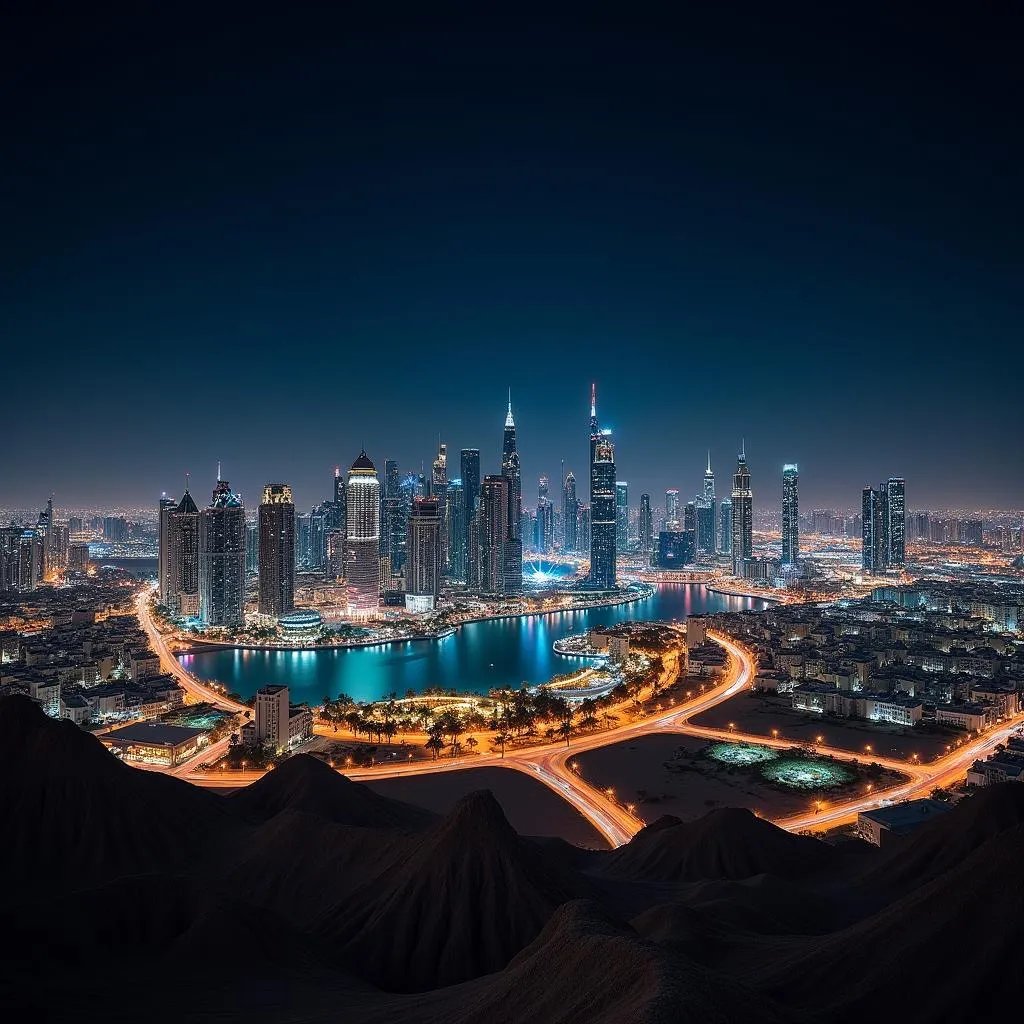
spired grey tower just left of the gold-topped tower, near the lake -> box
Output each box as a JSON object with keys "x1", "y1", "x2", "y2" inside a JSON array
[{"x1": 199, "y1": 475, "x2": 246, "y2": 628}]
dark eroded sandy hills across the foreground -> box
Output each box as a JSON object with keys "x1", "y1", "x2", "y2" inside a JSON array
[{"x1": 0, "y1": 697, "x2": 1024, "y2": 1024}]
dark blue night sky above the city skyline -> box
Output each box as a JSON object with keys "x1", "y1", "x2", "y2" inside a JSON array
[{"x1": 0, "y1": 4, "x2": 1024, "y2": 509}]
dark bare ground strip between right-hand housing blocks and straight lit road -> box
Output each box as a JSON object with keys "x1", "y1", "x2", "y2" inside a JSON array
[{"x1": 693, "y1": 693, "x2": 955, "y2": 761}]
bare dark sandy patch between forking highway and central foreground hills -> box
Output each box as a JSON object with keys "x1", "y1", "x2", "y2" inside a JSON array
[{"x1": 364, "y1": 768, "x2": 608, "y2": 850}]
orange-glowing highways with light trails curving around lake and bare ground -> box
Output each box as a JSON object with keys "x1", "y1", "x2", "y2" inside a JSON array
[{"x1": 148, "y1": 592, "x2": 1024, "y2": 847}]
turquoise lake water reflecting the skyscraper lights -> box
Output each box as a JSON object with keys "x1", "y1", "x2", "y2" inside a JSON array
[{"x1": 181, "y1": 584, "x2": 761, "y2": 702}]
